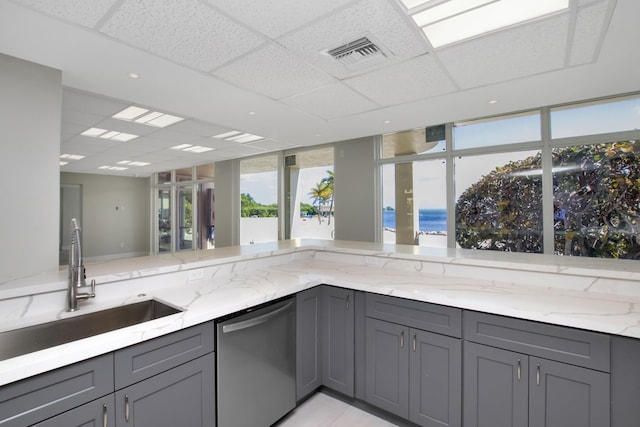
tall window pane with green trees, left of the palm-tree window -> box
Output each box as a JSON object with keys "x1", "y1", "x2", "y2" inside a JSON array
[{"x1": 240, "y1": 155, "x2": 278, "y2": 245}]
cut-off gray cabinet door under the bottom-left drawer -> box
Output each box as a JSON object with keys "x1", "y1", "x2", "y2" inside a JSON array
[{"x1": 34, "y1": 394, "x2": 116, "y2": 427}]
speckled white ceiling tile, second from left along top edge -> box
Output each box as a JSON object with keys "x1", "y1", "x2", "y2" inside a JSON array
[{"x1": 101, "y1": 0, "x2": 265, "y2": 72}]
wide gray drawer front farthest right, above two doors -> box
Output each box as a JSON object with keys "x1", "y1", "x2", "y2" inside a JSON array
[{"x1": 464, "y1": 311, "x2": 611, "y2": 372}]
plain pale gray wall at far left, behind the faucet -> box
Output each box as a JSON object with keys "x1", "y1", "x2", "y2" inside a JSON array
[{"x1": 0, "y1": 54, "x2": 62, "y2": 282}]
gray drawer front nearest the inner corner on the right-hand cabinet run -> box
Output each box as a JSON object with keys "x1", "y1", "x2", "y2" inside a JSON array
[{"x1": 366, "y1": 293, "x2": 462, "y2": 338}]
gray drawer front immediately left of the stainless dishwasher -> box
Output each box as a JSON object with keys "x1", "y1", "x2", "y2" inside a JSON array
[{"x1": 115, "y1": 322, "x2": 214, "y2": 390}]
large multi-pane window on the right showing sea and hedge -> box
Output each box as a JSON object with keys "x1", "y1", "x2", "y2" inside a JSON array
[{"x1": 380, "y1": 95, "x2": 640, "y2": 259}]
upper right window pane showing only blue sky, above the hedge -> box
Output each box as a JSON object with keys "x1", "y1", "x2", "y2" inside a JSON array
[{"x1": 551, "y1": 96, "x2": 640, "y2": 138}]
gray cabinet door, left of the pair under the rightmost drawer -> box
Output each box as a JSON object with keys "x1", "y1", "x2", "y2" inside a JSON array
[{"x1": 463, "y1": 341, "x2": 528, "y2": 427}]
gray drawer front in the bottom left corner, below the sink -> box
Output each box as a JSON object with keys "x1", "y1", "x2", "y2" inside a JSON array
[{"x1": 0, "y1": 353, "x2": 113, "y2": 427}]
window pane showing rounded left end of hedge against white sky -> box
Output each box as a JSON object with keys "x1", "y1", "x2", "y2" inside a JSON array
[{"x1": 455, "y1": 151, "x2": 543, "y2": 253}]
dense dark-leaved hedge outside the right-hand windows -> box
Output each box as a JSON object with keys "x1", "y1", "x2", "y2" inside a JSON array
[{"x1": 456, "y1": 141, "x2": 640, "y2": 259}]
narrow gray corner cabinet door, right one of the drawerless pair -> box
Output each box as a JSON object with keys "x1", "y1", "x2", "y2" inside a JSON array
[{"x1": 322, "y1": 286, "x2": 355, "y2": 397}]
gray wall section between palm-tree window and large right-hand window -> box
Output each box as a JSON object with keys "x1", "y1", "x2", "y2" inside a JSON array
[{"x1": 334, "y1": 137, "x2": 378, "y2": 242}]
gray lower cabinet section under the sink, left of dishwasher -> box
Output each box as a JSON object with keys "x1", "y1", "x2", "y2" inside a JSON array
[{"x1": 0, "y1": 322, "x2": 216, "y2": 427}]
